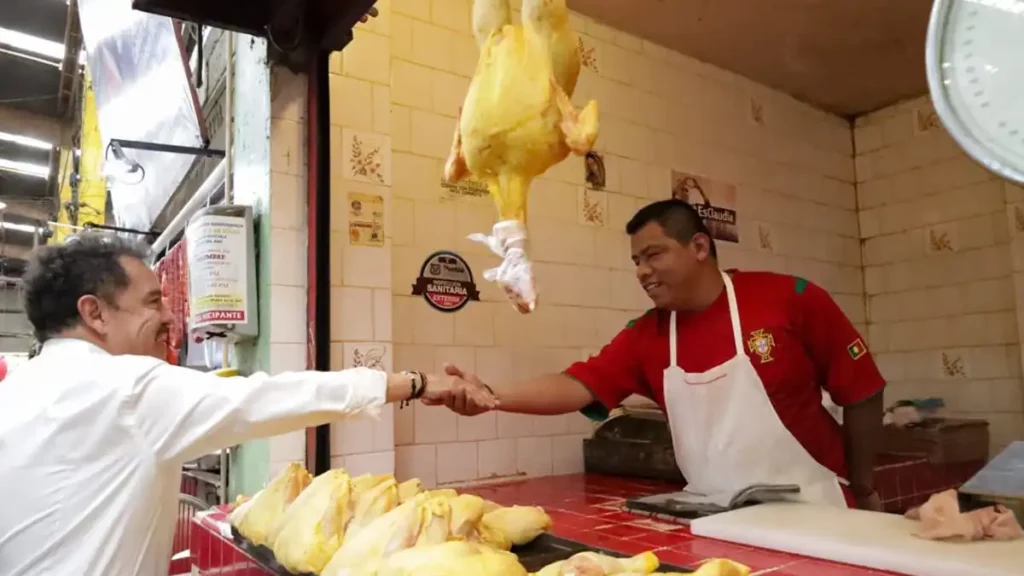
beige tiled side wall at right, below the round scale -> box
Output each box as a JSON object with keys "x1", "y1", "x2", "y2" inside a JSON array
[{"x1": 855, "y1": 97, "x2": 1024, "y2": 450}]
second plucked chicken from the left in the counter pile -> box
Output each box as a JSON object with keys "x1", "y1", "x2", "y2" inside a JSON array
[{"x1": 271, "y1": 469, "x2": 351, "y2": 574}]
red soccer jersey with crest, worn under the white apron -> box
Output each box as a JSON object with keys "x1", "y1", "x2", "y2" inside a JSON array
[{"x1": 565, "y1": 271, "x2": 885, "y2": 478}]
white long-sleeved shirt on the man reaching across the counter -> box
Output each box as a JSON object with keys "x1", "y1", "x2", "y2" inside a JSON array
[{"x1": 0, "y1": 339, "x2": 387, "y2": 576}]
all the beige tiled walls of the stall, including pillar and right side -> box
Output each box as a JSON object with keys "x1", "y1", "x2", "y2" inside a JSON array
[{"x1": 290, "y1": 0, "x2": 1024, "y2": 485}]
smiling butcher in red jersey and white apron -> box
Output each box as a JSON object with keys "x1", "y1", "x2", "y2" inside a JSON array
[{"x1": 436, "y1": 200, "x2": 885, "y2": 509}]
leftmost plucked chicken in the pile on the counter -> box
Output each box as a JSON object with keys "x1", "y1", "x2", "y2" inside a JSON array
[{"x1": 228, "y1": 462, "x2": 312, "y2": 546}]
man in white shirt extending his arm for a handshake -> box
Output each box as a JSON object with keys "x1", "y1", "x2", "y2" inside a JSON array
[{"x1": 0, "y1": 234, "x2": 494, "y2": 576}]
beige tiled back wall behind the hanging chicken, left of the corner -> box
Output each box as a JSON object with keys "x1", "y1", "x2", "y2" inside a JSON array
[{"x1": 372, "y1": 0, "x2": 864, "y2": 485}]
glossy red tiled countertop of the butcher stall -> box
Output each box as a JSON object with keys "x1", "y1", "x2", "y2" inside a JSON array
[{"x1": 191, "y1": 456, "x2": 981, "y2": 576}]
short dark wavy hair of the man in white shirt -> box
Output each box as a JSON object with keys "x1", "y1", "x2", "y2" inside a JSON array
[{"x1": 22, "y1": 232, "x2": 148, "y2": 343}]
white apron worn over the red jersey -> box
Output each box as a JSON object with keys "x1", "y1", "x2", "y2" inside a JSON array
[{"x1": 664, "y1": 273, "x2": 847, "y2": 507}]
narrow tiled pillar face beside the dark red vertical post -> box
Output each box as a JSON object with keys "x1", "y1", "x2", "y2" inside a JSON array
[{"x1": 330, "y1": 7, "x2": 401, "y2": 474}]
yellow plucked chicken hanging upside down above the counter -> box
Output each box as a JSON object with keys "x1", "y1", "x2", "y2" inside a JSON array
[{"x1": 444, "y1": 0, "x2": 598, "y2": 314}]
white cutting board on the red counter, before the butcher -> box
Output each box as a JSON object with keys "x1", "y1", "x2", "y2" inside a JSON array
[{"x1": 690, "y1": 502, "x2": 1024, "y2": 576}]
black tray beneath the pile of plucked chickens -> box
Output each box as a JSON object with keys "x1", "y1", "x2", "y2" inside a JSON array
[{"x1": 231, "y1": 526, "x2": 693, "y2": 576}]
